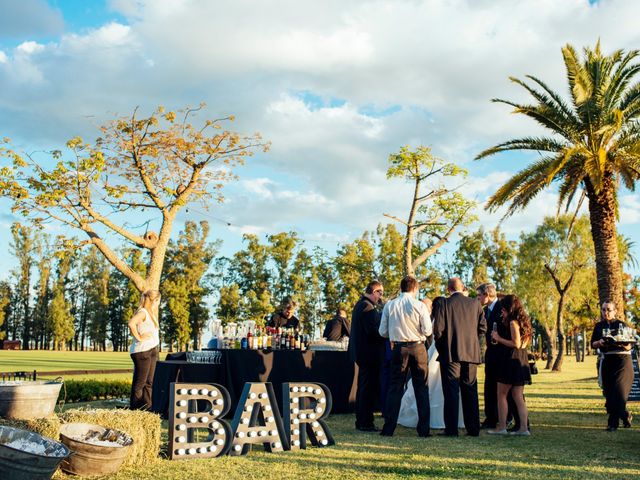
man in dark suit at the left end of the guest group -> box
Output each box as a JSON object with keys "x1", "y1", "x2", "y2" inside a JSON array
[{"x1": 349, "y1": 280, "x2": 385, "y2": 432}]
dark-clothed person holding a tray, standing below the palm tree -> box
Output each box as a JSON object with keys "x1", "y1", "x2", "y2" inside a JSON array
[{"x1": 591, "y1": 302, "x2": 633, "y2": 432}]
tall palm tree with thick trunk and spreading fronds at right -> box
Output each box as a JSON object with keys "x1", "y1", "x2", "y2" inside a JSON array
[{"x1": 476, "y1": 41, "x2": 640, "y2": 312}]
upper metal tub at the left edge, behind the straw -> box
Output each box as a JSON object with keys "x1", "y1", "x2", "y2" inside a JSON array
[{"x1": 0, "y1": 380, "x2": 62, "y2": 420}]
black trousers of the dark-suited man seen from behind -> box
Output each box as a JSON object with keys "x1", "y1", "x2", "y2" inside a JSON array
[{"x1": 440, "y1": 362, "x2": 480, "y2": 436}]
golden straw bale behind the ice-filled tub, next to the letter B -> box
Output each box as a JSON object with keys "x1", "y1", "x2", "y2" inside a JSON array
[{"x1": 60, "y1": 408, "x2": 161, "y2": 466}]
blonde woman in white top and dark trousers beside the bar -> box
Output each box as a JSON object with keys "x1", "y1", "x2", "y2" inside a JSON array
[{"x1": 129, "y1": 290, "x2": 160, "y2": 410}]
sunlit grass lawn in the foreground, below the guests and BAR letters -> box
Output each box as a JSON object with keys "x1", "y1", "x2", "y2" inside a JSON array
[{"x1": 27, "y1": 354, "x2": 640, "y2": 480}]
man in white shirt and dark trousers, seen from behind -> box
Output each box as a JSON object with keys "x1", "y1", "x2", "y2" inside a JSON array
[{"x1": 379, "y1": 277, "x2": 432, "y2": 437}]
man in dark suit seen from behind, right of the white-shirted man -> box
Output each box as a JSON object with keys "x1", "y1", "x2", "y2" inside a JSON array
[{"x1": 433, "y1": 277, "x2": 487, "y2": 437}]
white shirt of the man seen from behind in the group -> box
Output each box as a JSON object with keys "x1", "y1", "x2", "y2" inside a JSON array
[{"x1": 378, "y1": 292, "x2": 433, "y2": 342}]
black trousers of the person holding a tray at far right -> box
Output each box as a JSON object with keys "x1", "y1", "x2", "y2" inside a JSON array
[{"x1": 601, "y1": 355, "x2": 633, "y2": 428}]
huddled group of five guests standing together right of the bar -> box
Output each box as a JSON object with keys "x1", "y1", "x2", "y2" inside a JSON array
[{"x1": 349, "y1": 276, "x2": 533, "y2": 437}]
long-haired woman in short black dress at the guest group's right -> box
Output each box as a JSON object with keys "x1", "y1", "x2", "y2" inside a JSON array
[{"x1": 488, "y1": 295, "x2": 533, "y2": 435}]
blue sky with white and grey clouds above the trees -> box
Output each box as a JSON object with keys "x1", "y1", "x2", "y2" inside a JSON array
[{"x1": 0, "y1": 0, "x2": 640, "y2": 278}]
